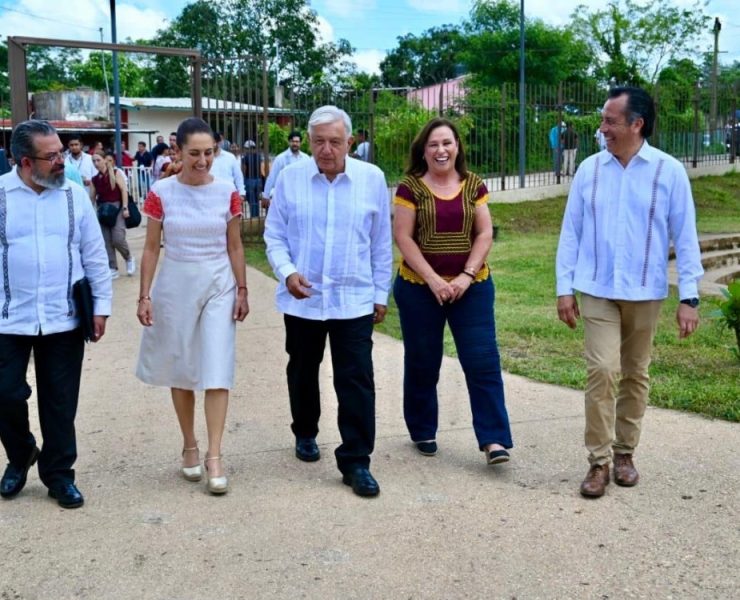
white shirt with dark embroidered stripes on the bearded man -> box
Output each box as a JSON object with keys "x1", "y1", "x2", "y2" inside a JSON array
[{"x1": 0, "y1": 169, "x2": 113, "y2": 335}]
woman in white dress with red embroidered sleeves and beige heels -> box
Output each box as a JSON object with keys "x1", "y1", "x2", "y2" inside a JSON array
[{"x1": 136, "y1": 118, "x2": 249, "y2": 494}]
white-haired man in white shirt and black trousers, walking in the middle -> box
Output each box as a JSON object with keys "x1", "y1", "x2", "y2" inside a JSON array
[{"x1": 265, "y1": 106, "x2": 392, "y2": 496}]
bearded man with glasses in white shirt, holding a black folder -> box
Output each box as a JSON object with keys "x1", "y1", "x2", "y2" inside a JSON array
[{"x1": 0, "y1": 121, "x2": 112, "y2": 508}]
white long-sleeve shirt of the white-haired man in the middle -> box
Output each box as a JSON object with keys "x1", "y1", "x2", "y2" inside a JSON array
[{"x1": 265, "y1": 157, "x2": 393, "y2": 321}]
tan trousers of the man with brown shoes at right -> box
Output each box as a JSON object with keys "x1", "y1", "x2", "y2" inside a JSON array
[{"x1": 581, "y1": 294, "x2": 662, "y2": 464}]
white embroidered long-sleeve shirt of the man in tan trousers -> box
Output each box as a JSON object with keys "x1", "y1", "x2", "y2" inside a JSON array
[{"x1": 556, "y1": 142, "x2": 704, "y2": 301}]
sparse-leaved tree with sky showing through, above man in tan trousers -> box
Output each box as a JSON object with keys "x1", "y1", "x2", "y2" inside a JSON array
[{"x1": 571, "y1": 0, "x2": 710, "y2": 84}]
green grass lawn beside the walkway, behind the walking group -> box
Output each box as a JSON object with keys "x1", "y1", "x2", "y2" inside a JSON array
[{"x1": 246, "y1": 173, "x2": 740, "y2": 421}]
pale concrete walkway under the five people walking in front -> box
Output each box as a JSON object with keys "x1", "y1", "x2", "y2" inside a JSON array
[{"x1": 0, "y1": 230, "x2": 740, "y2": 600}]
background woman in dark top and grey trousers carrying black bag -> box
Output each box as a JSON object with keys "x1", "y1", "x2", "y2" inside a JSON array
[{"x1": 92, "y1": 152, "x2": 136, "y2": 279}]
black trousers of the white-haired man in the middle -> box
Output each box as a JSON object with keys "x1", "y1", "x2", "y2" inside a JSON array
[{"x1": 285, "y1": 315, "x2": 375, "y2": 472}]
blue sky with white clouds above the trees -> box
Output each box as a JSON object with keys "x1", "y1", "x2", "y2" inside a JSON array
[{"x1": 0, "y1": 0, "x2": 740, "y2": 72}]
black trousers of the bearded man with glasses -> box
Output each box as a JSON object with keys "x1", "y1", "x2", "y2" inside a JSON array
[{"x1": 0, "y1": 329, "x2": 85, "y2": 488}]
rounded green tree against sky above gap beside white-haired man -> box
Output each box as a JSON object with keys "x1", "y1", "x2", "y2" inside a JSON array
[{"x1": 380, "y1": 25, "x2": 466, "y2": 87}]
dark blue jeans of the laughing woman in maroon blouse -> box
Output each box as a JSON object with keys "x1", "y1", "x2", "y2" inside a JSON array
[{"x1": 393, "y1": 276, "x2": 513, "y2": 450}]
